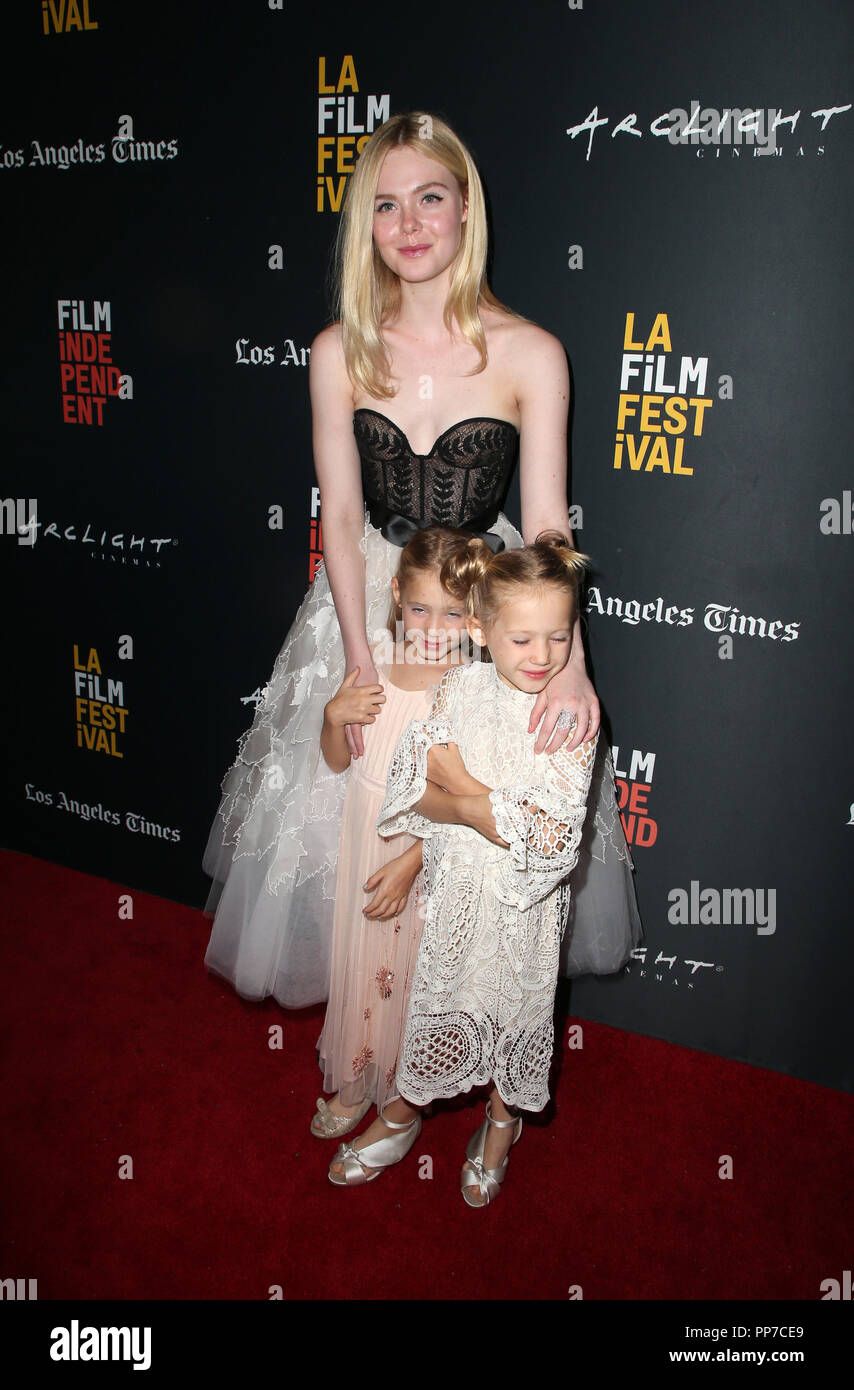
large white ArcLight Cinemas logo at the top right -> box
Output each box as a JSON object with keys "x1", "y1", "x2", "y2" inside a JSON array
[{"x1": 566, "y1": 99, "x2": 851, "y2": 161}]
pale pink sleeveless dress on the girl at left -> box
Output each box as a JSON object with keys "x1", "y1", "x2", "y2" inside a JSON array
[{"x1": 317, "y1": 666, "x2": 435, "y2": 1106}]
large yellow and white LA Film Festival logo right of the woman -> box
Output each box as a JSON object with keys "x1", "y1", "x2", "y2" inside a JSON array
[{"x1": 613, "y1": 314, "x2": 732, "y2": 478}]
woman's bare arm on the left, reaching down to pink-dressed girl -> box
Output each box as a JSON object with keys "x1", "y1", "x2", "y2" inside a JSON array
[{"x1": 309, "y1": 324, "x2": 377, "y2": 758}]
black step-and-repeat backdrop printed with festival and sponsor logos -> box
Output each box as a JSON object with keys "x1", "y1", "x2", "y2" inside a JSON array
[{"x1": 0, "y1": 0, "x2": 854, "y2": 1088}]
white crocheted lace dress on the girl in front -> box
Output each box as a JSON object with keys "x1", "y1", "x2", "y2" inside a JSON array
[{"x1": 377, "y1": 662, "x2": 597, "y2": 1111}]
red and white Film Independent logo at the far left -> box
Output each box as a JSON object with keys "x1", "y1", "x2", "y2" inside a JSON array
[{"x1": 57, "y1": 299, "x2": 134, "y2": 425}]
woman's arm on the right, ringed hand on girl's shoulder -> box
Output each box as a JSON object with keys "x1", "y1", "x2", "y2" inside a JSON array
[{"x1": 513, "y1": 324, "x2": 601, "y2": 753}]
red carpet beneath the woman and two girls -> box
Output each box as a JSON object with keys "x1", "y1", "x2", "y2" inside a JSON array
[{"x1": 0, "y1": 853, "x2": 854, "y2": 1300}]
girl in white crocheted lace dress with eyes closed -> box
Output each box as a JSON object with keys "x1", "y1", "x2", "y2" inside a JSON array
[{"x1": 332, "y1": 534, "x2": 595, "y2": 1207}]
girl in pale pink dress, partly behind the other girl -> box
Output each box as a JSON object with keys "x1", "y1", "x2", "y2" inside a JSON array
[{"x1": 312, "y1": 527, "x2": 470, "y2": 1138}]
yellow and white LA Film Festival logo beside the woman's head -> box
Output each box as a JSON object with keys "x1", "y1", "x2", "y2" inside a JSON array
[{"x1": 316, "y1": 53, "x2": 391, "y2": 213}]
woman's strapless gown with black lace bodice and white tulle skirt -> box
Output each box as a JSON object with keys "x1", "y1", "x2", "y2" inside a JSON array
[{"x1": 203, "y1": 409, "x2": 641, "y2": 1008}]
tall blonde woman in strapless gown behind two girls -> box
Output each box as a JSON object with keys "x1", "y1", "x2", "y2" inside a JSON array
[{"x1": 204, "y1": 113, "x2": 638, "y2": 1078}]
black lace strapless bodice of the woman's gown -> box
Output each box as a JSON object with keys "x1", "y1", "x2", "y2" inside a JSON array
[{"x1": 353, "y1": 407, "x2": 519, "y2": 527}]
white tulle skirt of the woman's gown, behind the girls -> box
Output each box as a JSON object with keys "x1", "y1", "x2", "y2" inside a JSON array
[{"x1": 203, "y1": 514, "x2": 641, "y2": 1009}]
